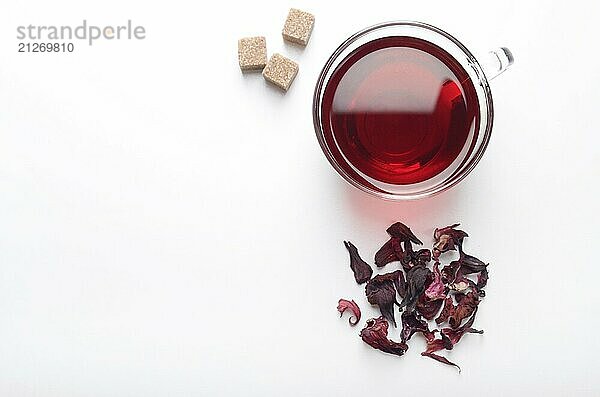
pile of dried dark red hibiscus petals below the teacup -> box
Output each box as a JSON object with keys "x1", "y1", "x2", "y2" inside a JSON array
[{"x1": 338, "y1": 222, "x2": 489, "y2": 371}]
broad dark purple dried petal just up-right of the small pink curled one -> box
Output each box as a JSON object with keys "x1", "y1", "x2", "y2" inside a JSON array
[{"x1": 365, "y1": 270, "x2": 404, "y2": 327}]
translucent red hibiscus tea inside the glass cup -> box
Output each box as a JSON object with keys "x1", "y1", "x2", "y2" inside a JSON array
[{"x1": 321, "y1": 36, "x2": 480, "y2": 185}]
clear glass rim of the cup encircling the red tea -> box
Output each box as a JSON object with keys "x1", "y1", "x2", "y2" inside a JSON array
[{"x1": 313, "y1": 21, "x2": 494, "y2": 201}]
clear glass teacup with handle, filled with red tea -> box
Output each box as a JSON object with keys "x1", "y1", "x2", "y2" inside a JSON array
[{"x1": 313, "y1": 21, "x2": 513, "y2": 200}]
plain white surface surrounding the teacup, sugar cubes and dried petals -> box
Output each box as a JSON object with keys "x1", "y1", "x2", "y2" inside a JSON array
[{"x1": 0, "y1": 0, "x2": 600, "y2": 397}]
